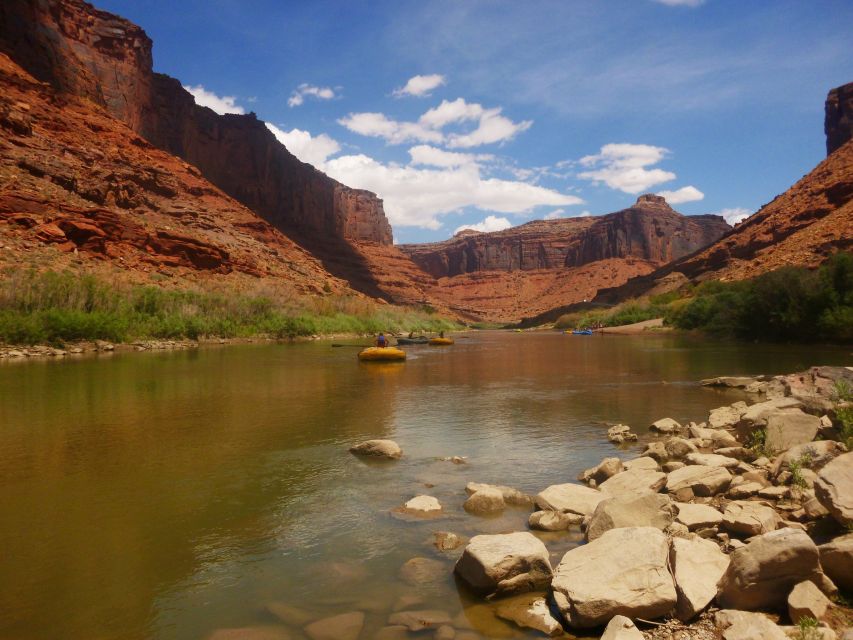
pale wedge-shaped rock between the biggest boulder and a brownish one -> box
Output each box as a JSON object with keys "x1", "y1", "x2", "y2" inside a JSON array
[{"x1": 669, "y1": 538, "x2": 729, "y2": 621}]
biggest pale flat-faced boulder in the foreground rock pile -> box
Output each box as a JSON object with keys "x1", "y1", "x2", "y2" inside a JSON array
[{"x1": 551, "y1": 527, "x2": 676, "y2": 627}]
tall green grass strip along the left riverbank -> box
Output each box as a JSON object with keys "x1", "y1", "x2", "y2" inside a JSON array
[{"x1": 0, "y1": 272, "x2": 456, "y2": 344}]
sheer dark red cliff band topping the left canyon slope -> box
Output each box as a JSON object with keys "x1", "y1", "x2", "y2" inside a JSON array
[{"x1": 0, "y1": 0, "x2": 392, "y2": 264}]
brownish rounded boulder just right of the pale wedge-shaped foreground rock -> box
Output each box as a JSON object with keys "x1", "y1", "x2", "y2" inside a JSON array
[{"x1": 717, "y1": 529, "x2": 822, "y2": 610}]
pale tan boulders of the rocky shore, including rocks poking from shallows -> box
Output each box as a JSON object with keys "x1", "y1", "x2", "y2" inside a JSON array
[{"x1": 322, "y1": 367, "x2": 853, "y2": 640}]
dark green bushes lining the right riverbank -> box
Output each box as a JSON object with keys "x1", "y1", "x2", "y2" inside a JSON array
[{"x1": 556, "y1": 253, "x2": 853, "y2": 343}]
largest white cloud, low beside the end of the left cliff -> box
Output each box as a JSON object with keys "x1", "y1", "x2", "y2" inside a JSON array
[{"x1": 322, "y1": 150, "x2": 583, "y2": 229}]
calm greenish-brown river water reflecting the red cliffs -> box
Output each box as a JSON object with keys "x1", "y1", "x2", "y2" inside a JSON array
[{"x1": 0, "y1": 332, "x2": 850, "y2": 640}]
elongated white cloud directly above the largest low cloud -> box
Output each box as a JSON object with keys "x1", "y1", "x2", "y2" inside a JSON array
[{"x1": 338, "y1": 98, "x2": 533, "y2": 148}]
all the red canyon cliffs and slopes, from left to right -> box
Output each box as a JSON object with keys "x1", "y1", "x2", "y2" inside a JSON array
[{"x1": 0, "y1": 0, "x2": 853, "y2": 322}]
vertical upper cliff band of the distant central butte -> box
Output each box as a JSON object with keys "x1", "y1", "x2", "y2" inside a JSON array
[{"x1": 400, "y1": 195, "x2": 730, "y2": 278}]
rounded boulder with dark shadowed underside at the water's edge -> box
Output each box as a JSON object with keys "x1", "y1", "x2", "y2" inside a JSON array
[{"x1": 455, "y1": 531, "x2": 553, "y2": 595}]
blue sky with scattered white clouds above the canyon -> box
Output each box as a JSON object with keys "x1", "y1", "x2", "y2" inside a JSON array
[{"x1": 94, "y1": 0, "x2": 853, "y2": 242}]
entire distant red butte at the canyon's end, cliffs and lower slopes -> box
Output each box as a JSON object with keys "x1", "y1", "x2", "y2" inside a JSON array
[{"x1": 400, "y1": 194, "x2": 730, "y2": 321}]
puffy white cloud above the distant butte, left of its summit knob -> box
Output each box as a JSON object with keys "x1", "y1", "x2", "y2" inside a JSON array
[{"x1": 578, "y1": 143, "x2": 676, "y2": 193}]
